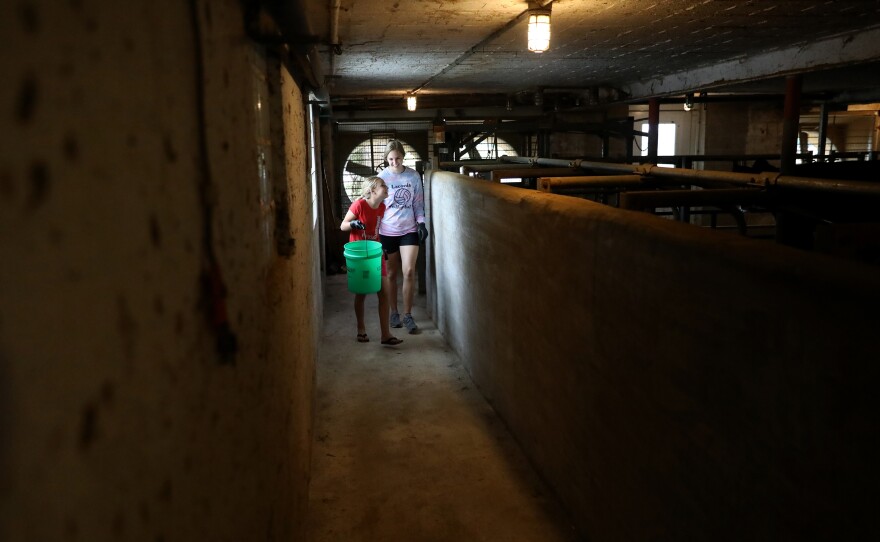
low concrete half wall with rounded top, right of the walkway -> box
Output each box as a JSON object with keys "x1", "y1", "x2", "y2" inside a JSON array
[{"x1": 428, "y1": 172, "x2": 880, "y2": 540}]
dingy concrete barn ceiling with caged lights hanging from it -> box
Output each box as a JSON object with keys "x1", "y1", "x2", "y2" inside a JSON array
[{"x1": 280, "y1": 0, "x2": 880, "y2": 112}]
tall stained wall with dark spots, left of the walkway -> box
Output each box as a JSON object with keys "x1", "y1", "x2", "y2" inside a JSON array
[{"x1": 0, "y1": 0, "x2": 321, "y2": 541}]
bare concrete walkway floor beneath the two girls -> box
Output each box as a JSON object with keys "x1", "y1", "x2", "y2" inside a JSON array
[{"x1": 309, "y1": 275, "x2": 577, "y2": 542}]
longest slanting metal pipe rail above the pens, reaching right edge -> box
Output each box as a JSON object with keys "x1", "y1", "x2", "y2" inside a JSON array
[{"x1": 501, "y1": 156, "x2": 880, "y2": 196}]
